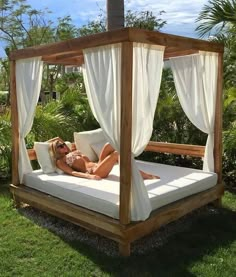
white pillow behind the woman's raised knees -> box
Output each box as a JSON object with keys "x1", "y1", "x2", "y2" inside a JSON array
[{"x1": 74, "y1": 128, "x2": 106, "y2": 162}]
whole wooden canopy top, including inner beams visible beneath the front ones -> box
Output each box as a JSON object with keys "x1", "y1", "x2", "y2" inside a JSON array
[{"x1": 10, "y1": 28, "x2": 224, "y2": 65}]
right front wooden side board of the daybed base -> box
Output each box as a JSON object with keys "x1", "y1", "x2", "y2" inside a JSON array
[{"x1": 125, "y1": 184, "x2": 224, "y2": 242}]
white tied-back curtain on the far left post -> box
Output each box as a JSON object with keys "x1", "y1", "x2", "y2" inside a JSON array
[{"x1": 16, "y1": 57, "x2": 43, "y2": 183}]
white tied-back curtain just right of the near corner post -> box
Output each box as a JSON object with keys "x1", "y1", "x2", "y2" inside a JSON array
[{"x1": 131, "y1": 43, "x2": 165, "y2": 220}]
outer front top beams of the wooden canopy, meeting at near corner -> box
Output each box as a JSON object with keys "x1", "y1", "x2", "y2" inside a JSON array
[{"x1": 10, "y1": 28, "x2": 224, "y2": 60}]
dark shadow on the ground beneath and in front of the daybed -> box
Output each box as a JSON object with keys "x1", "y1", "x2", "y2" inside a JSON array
[{"x1": 14, "y1": 196, "x2": 236, "y2": 277}]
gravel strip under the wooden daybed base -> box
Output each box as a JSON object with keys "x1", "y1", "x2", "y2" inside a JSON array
[{"x1": 18, "y1": 206, "x2": 217, "y2": 257}]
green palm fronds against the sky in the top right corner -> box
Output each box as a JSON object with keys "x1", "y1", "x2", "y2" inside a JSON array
[{"x1": 196, "y1": 0, "x2": 236, "y2": 37}]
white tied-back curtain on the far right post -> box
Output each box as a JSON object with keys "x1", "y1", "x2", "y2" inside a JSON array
[{"x1": 170, "y1": 52, "x2": 218, "y2": 171}]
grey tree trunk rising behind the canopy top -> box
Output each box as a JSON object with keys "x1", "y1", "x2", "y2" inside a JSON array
[{"x1": 107, "y1": 0, "x2": 124, "y2": 31}]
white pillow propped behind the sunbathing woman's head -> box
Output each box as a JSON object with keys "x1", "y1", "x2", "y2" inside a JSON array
[{"x1": 34, "y1": 141, "x2": 71, "y2": 174}]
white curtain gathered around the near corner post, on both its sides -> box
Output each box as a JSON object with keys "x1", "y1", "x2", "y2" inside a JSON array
[{"x1": 83, "y1": 43, "x2": 164, "y2": 221}]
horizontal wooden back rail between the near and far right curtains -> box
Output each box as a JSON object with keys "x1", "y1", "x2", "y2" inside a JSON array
[{"x1": 145, "y1": 141, "x2": 205, "y2": 157}]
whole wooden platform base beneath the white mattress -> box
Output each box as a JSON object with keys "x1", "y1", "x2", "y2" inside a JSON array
[{"x1": 10, "y1": 184, "x2": 224, "y2": 256}]
